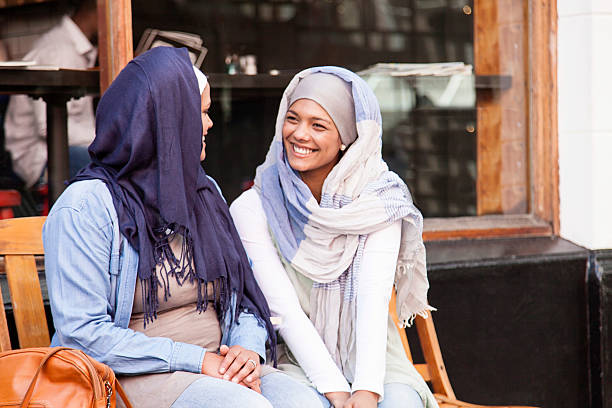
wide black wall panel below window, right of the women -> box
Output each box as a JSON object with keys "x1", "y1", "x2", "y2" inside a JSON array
[{"x1": 427, "y1": 238, "x2": 589, "y2": 408}]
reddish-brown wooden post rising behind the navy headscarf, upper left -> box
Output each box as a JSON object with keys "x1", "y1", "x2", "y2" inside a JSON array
[{"x1": 98, "y1": 0, "x2": 134, "y2": 95}]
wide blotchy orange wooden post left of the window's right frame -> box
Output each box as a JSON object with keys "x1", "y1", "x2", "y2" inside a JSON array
[{"x1": 474, "y1": 0, "x2": 529, "y2": 215}]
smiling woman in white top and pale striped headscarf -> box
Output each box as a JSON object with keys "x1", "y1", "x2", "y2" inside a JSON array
[{"x1": 230, "y1": 67, "x2": 437, "y2": 408}]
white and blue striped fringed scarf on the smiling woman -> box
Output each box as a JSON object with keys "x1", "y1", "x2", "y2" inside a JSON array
[{"x1": 254, "y1": 67, "x2": 434, "y2": 381}]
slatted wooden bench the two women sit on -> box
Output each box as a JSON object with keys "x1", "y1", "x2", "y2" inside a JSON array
[{"x1": 0, "y1": 217, "x2": 536, "y2": 408}]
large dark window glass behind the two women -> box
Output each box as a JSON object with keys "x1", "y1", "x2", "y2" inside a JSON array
[{"x1": 133, "y1": 0, "x2": 528, "y2": 217}]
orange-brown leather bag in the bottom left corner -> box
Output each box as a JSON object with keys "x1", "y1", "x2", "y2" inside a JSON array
[{"x1": 0, "y1": 347, "x2": 132, "y2": 408}]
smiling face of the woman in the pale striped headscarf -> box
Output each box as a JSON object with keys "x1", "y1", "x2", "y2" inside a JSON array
[{"x1": 283, "y1": 99, "x2": 342, "y2": 180}]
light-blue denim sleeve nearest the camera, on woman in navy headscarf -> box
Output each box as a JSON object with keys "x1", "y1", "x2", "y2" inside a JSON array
[{"x1": 43, "y1": 191, "x2": 206, "y2": 374}]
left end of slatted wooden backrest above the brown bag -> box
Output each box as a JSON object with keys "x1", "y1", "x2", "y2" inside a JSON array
[{"x1": 0, "y1": 217, "x2": 50, "y2": 351}]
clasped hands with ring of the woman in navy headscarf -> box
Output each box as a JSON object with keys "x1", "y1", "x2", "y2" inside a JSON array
[{"x1": 202, "y1": 344, "x2": 261, "y2": 394}]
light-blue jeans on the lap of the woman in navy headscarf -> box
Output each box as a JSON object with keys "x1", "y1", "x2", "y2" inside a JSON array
[{"x1": 170, "y1": 373, "x2": 323, "y2": 408}]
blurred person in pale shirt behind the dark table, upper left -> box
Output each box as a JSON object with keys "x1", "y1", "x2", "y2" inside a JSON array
[{"x1": 4, "y1": 0, "x2": 97, "y2": 187}]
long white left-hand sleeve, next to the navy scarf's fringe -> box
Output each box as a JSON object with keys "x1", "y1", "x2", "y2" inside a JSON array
[{"x1": 230, "y1": 189, "x2": 350, "y2": 393}]
